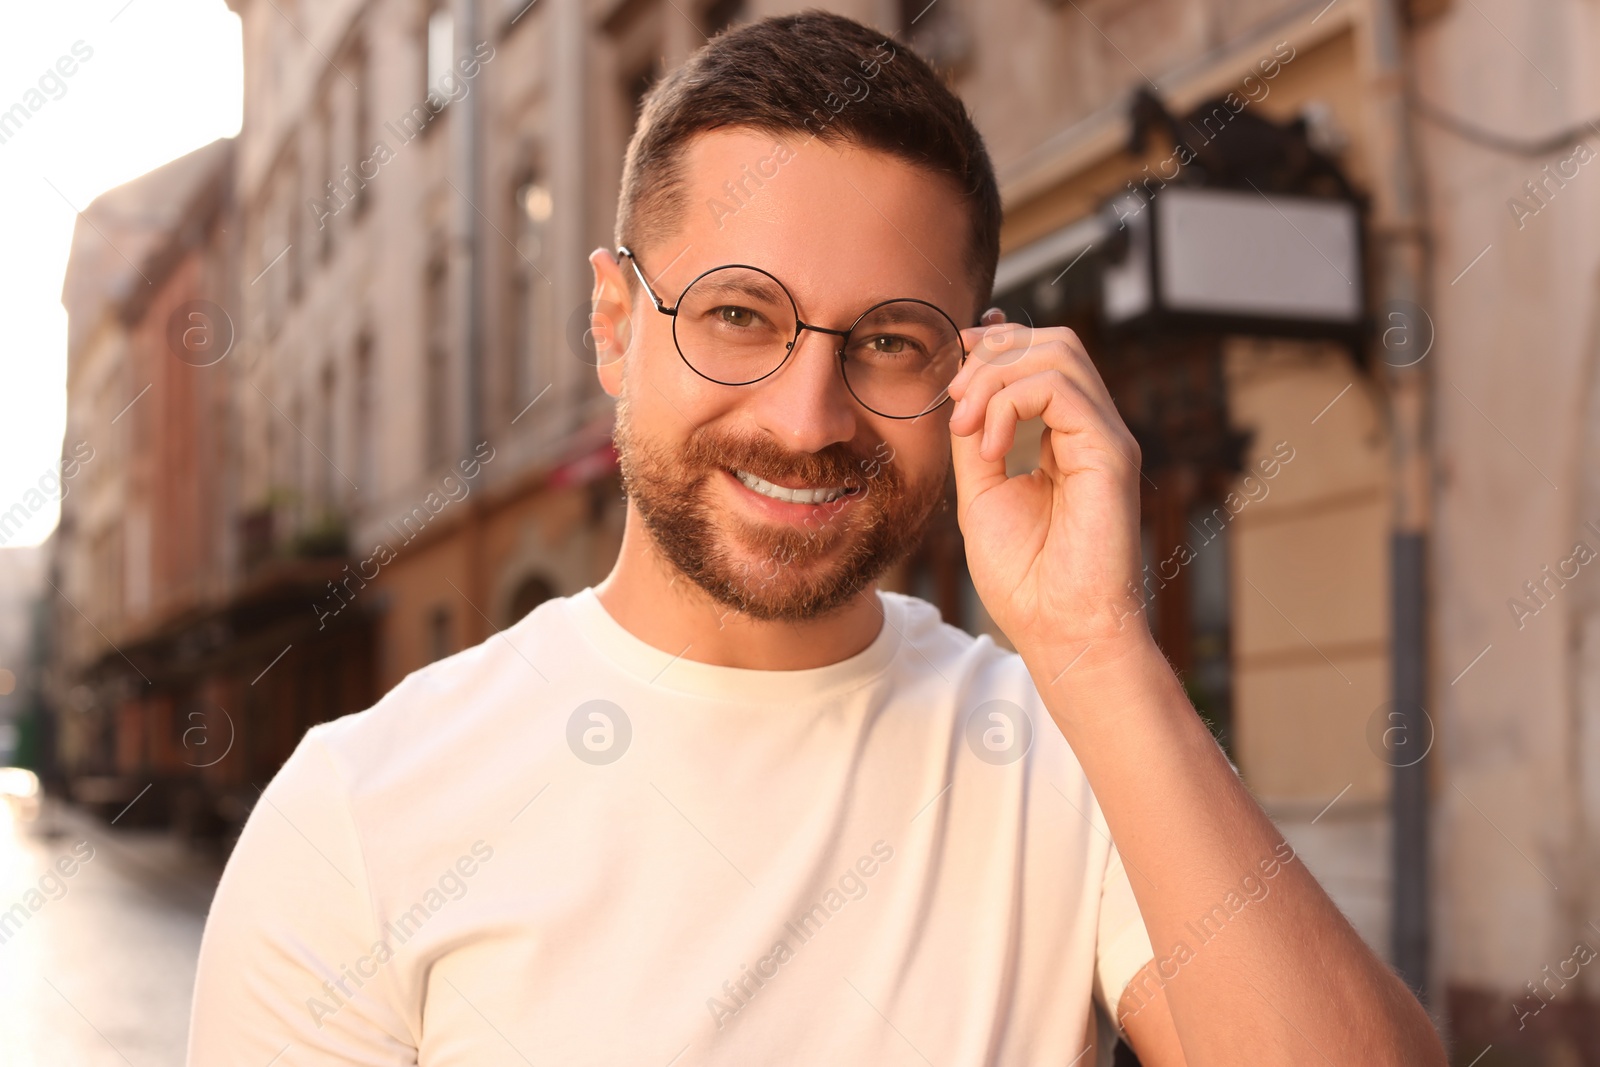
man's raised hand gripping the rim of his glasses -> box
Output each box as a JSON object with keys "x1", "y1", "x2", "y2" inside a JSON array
[{"x1": 950, "y1": 310, "x2": 1150, "y2": 665}]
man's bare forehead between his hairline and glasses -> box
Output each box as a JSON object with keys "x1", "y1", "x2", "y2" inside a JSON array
[{"x1": 650, "y1": 128, "x2": 976, "y2": 326}]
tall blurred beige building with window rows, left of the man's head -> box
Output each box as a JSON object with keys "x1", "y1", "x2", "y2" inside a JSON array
[{"x1": 224, "y1": 2, "x2": 630, "y2": 700}]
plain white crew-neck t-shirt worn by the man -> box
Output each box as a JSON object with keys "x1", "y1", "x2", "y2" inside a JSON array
[{"x1": 189, "y1": 589, "x2": 1152, "y2": 1067}]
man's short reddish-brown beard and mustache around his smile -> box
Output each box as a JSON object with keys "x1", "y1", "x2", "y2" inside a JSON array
[{"x1": 614, "y1": 386, "x2": 949, "y2": 622}]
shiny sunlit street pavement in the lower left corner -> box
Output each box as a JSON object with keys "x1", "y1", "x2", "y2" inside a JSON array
[{"x1": 0, "y1": 798, "x2": 221, "y2": 1067}]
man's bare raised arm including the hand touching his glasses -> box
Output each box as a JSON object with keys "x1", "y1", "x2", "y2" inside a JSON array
[{"x1": 950, "y1": 315, "x2": 1445, "y2": 1067}]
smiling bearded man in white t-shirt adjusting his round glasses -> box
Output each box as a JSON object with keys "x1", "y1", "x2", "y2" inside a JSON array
[{"x1": 190, "y1": 13, "x2": 1443, "y2": 1067}]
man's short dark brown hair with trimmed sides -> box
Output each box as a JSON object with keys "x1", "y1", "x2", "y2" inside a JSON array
[{"x1": 616, "y1": 8, "x2": 1000, "y2": 316}]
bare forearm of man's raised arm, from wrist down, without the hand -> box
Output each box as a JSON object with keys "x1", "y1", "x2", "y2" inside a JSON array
[{"x1": 1024, "y1": 639, "x2": 1443, "y2": 1067}]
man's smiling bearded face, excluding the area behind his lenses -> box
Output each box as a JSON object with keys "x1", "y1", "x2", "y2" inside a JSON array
[{"x1": 600, "y1": 128, "x2": 976, "y2": 621}]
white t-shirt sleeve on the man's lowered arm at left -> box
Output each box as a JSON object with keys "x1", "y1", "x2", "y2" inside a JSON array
[{"x1": 187, "y1": 728, "x2": 416, "y2": 1067}]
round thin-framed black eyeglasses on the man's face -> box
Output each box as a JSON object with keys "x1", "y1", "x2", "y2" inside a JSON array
[{"x1": 616, "y1": 245, "x2": 966, "y2": 419}]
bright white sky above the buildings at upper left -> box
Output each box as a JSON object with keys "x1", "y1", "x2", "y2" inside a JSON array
[{"x1": 0, "y1": 0, "x2": 243, "y2": 545}]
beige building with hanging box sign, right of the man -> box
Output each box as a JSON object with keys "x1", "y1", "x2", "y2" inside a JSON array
[{"x1": 936, "y1": 0, "x2": 1600, "y2": 1067}]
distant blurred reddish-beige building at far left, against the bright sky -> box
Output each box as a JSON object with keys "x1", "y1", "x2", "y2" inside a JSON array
[{"x1": 48, "y1": 141, "x2": 243, "y2": 821}]
